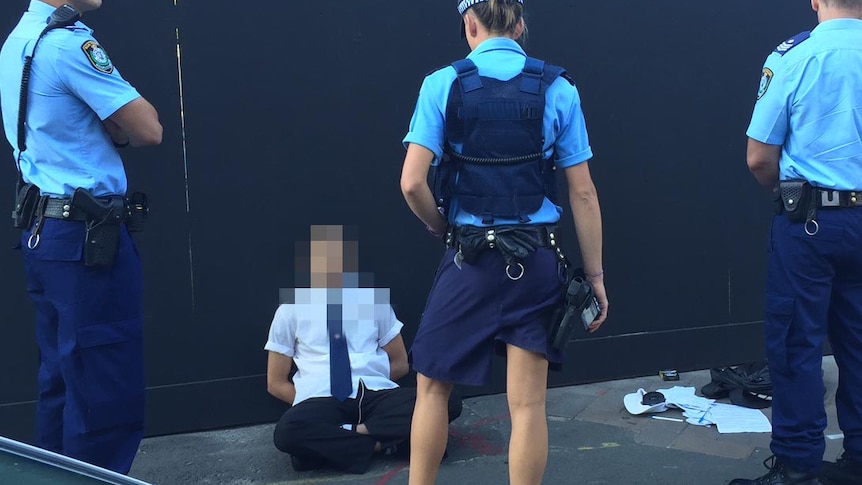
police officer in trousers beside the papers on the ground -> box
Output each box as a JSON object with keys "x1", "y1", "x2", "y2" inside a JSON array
[{"x1": 731, "y1": 0, "x2": 862, "y2": 485}]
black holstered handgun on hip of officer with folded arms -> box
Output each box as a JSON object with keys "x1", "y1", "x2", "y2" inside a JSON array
[{"x1": 70, "y1": 188, "x2": 126, "y2": 266}]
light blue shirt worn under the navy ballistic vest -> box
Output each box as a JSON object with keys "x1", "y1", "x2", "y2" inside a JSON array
[{"x1": 404, "y1": 37, "x2": 593, "y2": 226}]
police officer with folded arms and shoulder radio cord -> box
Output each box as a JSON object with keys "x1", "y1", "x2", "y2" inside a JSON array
[{"x1": 0, "y1": 0, "x2": 162, "y2": 473}]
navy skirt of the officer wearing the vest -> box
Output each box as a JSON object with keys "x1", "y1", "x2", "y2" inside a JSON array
[{"x1": 411, "y1": 248, "x2": 564, "y2": 386}]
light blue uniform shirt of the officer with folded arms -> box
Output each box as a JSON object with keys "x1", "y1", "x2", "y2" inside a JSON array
[{"x1": 0, "y1": 0, "x2": 140, "y2": 196}]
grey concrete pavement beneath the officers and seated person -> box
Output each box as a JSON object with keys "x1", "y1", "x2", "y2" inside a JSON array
[{"x1": 131, "y1": 357, "x2": 842, "y2": 485}]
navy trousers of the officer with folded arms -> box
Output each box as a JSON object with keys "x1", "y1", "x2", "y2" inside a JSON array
[{"x1": 21, "y1": 219, "x2": 144, "y2": 473}]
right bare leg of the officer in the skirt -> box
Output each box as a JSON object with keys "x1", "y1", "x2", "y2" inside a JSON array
[{"x1": 506, "y1": 345, "x2": 548, "y2": 485}]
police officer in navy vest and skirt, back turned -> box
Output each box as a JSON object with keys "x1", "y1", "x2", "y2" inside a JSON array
[{"x1": 401, "y1": 0, "x2": 608, "y2": 485}]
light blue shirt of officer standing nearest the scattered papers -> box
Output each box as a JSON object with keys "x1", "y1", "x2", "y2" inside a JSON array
[{"x1": 747, "y1": 19, "x2": 862, "y2": 190}]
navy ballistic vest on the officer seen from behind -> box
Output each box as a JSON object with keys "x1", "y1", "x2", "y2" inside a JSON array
[{"x1": 435, "y1": 57, "x2": 565, "y2": 224}]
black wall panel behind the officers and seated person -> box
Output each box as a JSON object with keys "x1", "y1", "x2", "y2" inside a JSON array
[{"x1": 0, "y1": 0, "x2": 816, "y2": 439}]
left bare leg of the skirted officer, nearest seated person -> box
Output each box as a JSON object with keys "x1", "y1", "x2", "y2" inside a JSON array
[{"x1": 409, "y1": 374, "x2": 452, "y2": 485}]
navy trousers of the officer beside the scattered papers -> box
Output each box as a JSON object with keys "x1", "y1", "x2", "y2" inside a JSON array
[{"x1": 766, "y1": 208, "x2": 862, "y2": 472}]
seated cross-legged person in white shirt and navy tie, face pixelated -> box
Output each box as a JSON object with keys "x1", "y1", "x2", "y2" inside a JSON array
[{"x1": 265, "y1": 226, "x2": 461, "y2": 473}]
